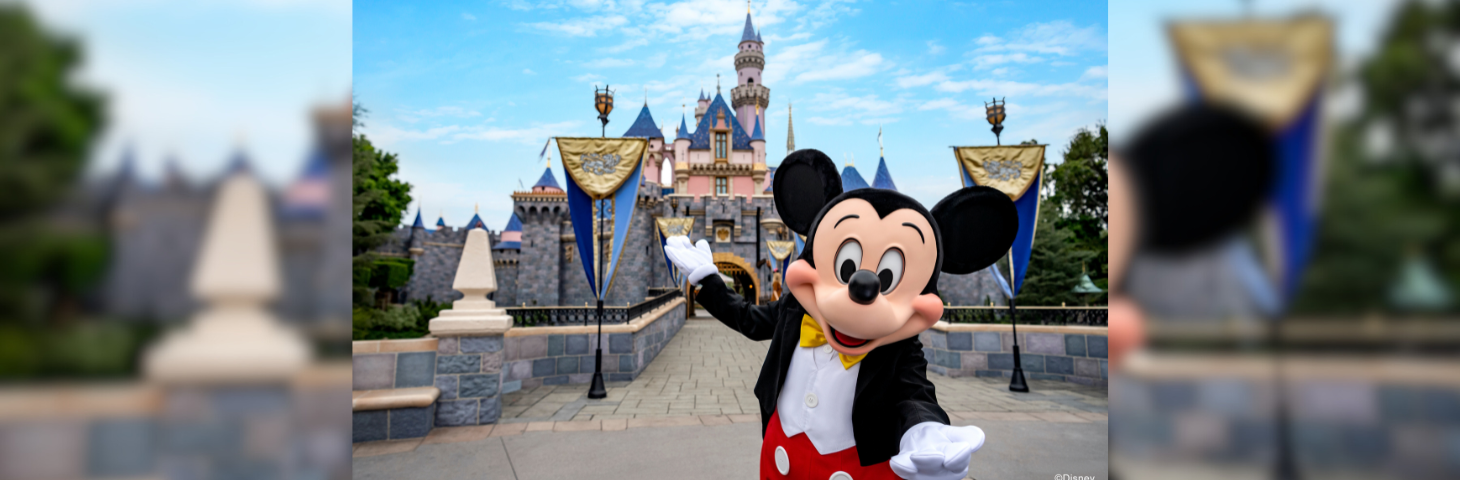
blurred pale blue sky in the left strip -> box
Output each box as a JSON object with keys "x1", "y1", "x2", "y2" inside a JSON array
[{"x1": 24, "y1": 0, "x2": 350, "y2": 185}]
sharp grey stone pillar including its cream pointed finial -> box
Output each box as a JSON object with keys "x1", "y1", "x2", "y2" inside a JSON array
[{"x1": 431, "y1": 229, "x2": 512, "y2": 426}]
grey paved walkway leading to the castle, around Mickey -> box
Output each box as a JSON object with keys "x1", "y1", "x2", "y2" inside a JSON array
[{"x1": 353, "y1": 318, "x2": 1108, "y2": 480}]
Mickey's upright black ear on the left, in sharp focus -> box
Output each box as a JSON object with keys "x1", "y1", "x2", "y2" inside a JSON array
[{"x1": 771, "y1": 149, "x2": 841, "y2": 235}]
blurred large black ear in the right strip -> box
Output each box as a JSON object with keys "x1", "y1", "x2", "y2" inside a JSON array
[{"x1": 1126, "y1": 104, "x2": 1276, "y2": 252}]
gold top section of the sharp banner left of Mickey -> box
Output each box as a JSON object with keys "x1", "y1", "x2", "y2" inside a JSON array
[{"x1": 558, "y1": 137, "x2": 648, "y2": 200}]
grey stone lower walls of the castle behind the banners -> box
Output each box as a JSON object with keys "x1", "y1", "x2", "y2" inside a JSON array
[{"x1": 381, "y1": 184, "x2": 1006, "y2": 306}]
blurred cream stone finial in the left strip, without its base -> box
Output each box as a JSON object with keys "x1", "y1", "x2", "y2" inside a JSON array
[{"x1": 143, "y1": 172, "x2": 310, "y2": 384}]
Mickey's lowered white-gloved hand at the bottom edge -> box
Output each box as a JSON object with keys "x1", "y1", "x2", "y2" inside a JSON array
[{"x1": 889, "y1": 422, "x2": 984, "y2": 480}]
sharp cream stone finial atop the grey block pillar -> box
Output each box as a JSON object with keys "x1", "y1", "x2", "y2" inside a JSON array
[{"x1": 431, "y1": 228, "x2": 512, "y2": 337}]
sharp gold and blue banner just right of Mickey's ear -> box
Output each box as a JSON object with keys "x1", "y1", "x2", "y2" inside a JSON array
[{"x1": 953, "y1": 144, "x2": 1045, "y2": 298}]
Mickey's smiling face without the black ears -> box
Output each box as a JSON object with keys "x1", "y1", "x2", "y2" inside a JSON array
[{"x1": 787, "y1": 198, "x2": 943, "y2": 355}]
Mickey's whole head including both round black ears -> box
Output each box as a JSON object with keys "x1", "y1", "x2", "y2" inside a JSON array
[{"x1": 772, "y1": 150, "x2": 1019, "y2": 355}]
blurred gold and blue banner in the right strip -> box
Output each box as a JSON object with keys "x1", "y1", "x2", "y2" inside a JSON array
[{"x1": 1169, "y1": 16, "x2": 1333, "y2": 301}]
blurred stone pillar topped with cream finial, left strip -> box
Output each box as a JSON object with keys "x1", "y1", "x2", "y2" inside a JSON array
[{"x1": 139, "y1": 172, "x2": 315, "y2": 479}]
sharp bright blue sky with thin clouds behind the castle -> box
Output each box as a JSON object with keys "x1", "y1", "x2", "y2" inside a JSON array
[{"x1": 353, "y1": 0, "x2": 1107, "y2": 228}]
